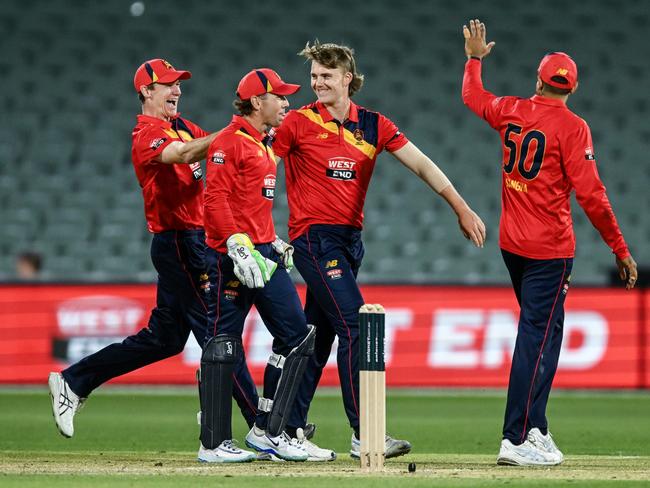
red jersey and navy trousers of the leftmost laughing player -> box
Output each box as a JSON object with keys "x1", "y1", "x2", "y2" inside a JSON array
[{"x1": 62, "y1": 115, "x2": 258, "y2": 426}]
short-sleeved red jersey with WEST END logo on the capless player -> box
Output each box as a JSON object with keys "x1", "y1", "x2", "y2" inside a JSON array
[{"x1": 273, "y1": 102, "x2": 408, "y2": 239}]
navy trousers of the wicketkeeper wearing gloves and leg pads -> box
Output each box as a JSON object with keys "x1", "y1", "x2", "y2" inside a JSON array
[{"x1": 206, "y1": 244, "x2": 308, "y2": 429}]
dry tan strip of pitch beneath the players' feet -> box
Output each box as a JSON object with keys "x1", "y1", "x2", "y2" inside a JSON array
[{"x1": 0, "y1": 451, "x2": 650, "y2": 481}]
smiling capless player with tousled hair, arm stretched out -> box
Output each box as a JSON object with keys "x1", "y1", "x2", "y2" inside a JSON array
[{"x1": 273, "y1": 41, "x2": 485, "y2": 458}]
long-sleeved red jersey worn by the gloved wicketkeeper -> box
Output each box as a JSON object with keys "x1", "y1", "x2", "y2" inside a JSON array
[{"x1": 205, "y1": 115, "x2": 277, "y2": 252}]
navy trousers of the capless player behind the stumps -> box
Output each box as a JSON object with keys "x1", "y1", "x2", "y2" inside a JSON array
[{"x1": 288, "y1": 225, "x2": 364, "y2": 433}]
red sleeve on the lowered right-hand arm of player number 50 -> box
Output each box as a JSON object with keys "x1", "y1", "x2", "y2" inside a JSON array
[{"x1": 561, "y1": 119, "x2": 630, "y2": 259}]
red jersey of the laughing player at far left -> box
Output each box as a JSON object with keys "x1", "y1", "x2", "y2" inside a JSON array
[{"x1": 131, "y1": 115, "x2": 208, "y2": 232}]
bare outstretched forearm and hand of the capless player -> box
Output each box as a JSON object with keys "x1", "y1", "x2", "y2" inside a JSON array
[{"x1": 391, "y1": 142, "x2": 485, "y2": 247}]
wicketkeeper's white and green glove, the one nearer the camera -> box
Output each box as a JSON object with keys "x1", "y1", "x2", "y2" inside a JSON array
[{"x1": 226, "y1": 234, "x2": 278, "y2": 288}]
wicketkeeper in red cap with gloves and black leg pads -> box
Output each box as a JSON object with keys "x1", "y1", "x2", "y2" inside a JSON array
[{"x1": 199, "y1": 68, "x2": 336, "y2": 462}]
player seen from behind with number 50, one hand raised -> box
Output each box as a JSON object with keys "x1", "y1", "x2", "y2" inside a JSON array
[{"x1": 463, "y1": 19, "x2": 637, "y2": 466}]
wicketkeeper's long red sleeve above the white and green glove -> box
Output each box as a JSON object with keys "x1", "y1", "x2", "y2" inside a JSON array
[{"x1": 204, "y1": 137, "x2": 240, "y2": 247}]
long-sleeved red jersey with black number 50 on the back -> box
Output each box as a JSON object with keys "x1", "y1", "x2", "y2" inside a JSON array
[{"x1": 463, "y1": 59, "x2": 630, "y2": 259}]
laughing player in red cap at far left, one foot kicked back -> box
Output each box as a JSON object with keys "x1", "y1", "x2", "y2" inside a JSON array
[{"x1": 49, "y1": 59, "x2": 258, "y2": 446}]
